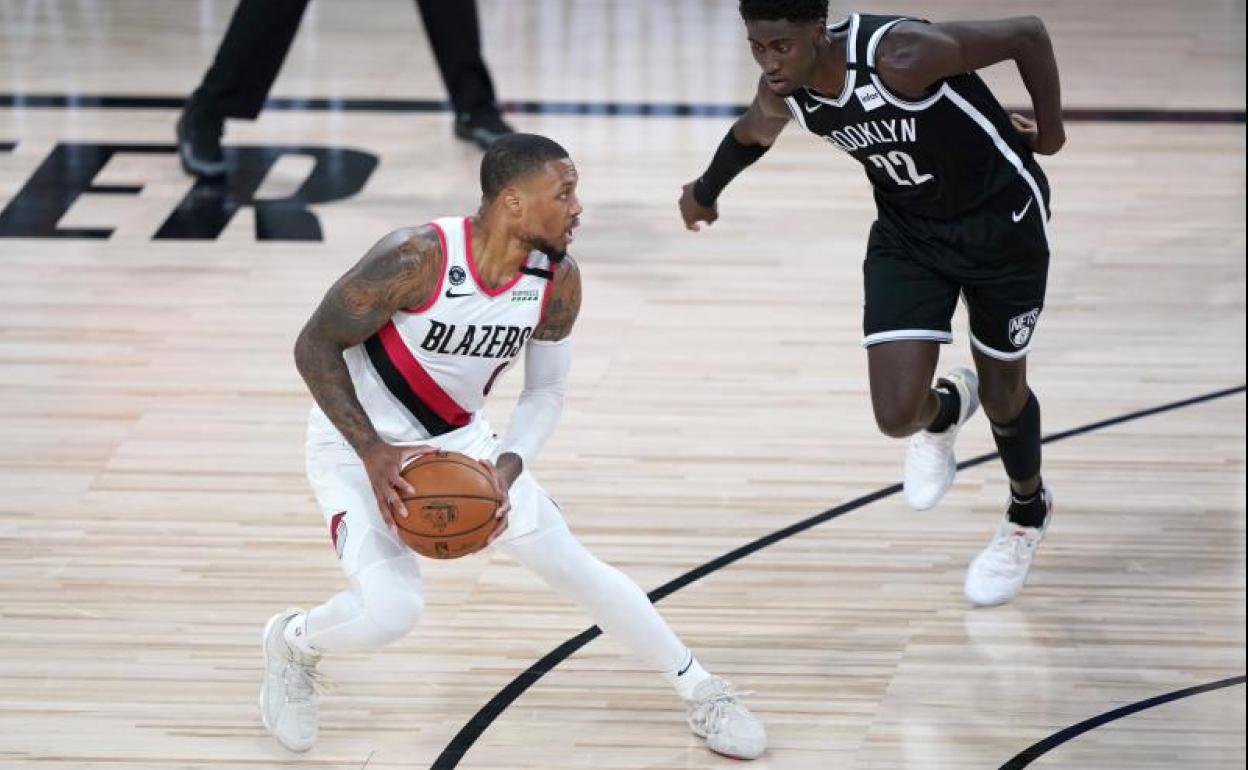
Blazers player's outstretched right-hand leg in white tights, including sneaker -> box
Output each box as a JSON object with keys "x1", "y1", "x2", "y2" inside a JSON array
[{"x1": 498, "y1": 493, "x2": 766, "y2": 759}]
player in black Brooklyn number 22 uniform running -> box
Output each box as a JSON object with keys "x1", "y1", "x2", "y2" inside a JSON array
[{"x1": 680, "y1": 0, "x2": 1066, "y2": 605}]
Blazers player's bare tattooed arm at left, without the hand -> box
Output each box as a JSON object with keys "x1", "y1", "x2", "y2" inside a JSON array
[{"x1": 295, "y1": 227, "x2": 442, "y2": 456}]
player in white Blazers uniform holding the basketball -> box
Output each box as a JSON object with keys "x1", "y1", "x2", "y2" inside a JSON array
[{"x1": 260, "y1": 134, "x2": 766, "y2": 759}]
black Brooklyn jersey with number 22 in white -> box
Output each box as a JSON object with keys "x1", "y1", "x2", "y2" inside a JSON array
[{"x1": 785, "y1": 14, "x2": 1048, "y2": 220}]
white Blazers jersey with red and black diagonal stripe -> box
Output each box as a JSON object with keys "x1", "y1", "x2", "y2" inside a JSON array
[{"x1": 343, "y1": 217, "x2": 554, "y2": 444}]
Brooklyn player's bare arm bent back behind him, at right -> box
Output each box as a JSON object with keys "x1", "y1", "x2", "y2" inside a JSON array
[{"x1": 876, "y1": 16, "x2": 1066, "y2": 155}]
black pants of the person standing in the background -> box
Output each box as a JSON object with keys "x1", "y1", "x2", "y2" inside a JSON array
[{"x1": 192, "y1": 0, "x2": 495, "y2": 119}]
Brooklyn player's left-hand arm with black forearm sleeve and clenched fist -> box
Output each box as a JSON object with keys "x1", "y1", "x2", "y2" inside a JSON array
[{"x1": 680, "y1": 77, "x2": 789, "y2": 231}]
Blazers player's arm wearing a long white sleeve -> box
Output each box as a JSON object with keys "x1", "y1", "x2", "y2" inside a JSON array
[{"x1": 497, "y1": 257, "x2": 580, "y2": 487}]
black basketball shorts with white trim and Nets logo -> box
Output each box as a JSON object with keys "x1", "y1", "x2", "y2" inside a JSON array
[{"x1": 862, "y1": 166, "x2": 1050, "y2": 361}]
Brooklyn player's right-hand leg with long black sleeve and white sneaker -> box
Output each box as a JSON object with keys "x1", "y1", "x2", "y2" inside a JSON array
[{"x1": 963, "y1": 346, "x2": 1053, "y2": 607}]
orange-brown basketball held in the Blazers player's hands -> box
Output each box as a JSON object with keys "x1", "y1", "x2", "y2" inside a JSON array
[{"x1": 394, "y1": 452, "x2": 499, "y2": 559}]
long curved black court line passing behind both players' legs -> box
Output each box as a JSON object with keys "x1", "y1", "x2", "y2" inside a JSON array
[{"x1": 429, "y1": 386, "x2": 1246, "y2": 770}]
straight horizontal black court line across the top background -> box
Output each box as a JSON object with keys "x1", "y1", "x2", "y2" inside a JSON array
[{"x1": 0, "y1": 94, "x2": 1244, "y2": 124}]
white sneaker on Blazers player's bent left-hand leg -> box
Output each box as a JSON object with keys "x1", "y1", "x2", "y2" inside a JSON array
[{"x1": 260, "y1": 608, "x2": 323, "y2": 751}]
